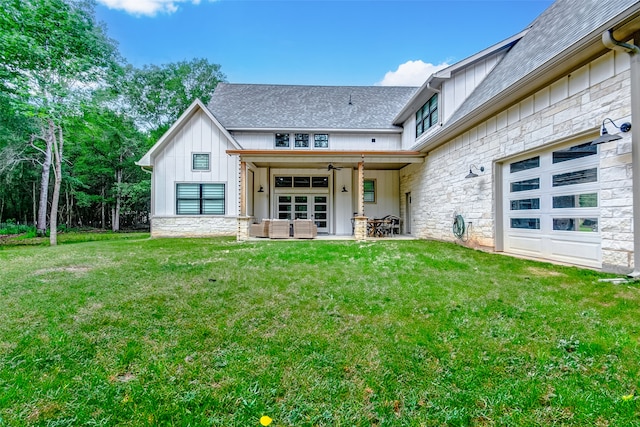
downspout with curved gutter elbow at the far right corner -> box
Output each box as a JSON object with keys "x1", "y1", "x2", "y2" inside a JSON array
[{"x1": 602, "y1": 30, "x2": 640, "y2": 278}]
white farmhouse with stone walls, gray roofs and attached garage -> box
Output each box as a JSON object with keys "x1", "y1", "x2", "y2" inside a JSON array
[{"x1": 138, "y1": 0, "x2": 640, "y2": 272}]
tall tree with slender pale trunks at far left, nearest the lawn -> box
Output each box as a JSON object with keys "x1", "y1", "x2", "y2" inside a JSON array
[{"x1": 0, "y1": 0, "x2": 117, "y2": 245}]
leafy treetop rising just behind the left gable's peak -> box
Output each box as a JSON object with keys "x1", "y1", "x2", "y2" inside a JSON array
[{"x1": 124, "y1": 58, "x2": 226, "y2": 140}]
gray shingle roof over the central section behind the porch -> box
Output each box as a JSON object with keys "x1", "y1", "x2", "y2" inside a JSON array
[{"x1": 208, "y1": 83, "x2": 418, "y2": 130}]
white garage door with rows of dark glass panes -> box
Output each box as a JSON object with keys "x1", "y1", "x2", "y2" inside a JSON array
[{"x1": 502, "y1": 143, "x2": 602, "y2": 268}]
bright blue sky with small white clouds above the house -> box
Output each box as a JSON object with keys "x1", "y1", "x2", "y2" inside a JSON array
[{"x1": 96, "y1": 0, "x2": 552, "y2": 85}]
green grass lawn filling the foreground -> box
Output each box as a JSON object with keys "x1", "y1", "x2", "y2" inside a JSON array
[{"x1": 0, "y1": 235, "x2": 640, "y2": 426}]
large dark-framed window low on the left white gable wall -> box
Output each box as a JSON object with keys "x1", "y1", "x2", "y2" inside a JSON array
[{"x1": 176, "y1": 184, "x2": 225, "y2": 215}]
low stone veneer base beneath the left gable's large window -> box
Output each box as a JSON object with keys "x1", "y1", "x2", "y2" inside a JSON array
[{"x1": 151, "y1": 216, "x2": 238, "y2": 237}]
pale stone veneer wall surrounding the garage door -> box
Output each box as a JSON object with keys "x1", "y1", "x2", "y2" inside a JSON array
[{"x1": 400, "y1": 52, "x2": 640, "y2": 272}]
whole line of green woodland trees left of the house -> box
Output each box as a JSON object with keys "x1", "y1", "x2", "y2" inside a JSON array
[{"x1": 0, "y1": 0, "x2": 225, "y2": 245}]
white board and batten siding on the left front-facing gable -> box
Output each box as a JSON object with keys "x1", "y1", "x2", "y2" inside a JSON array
[{"x1": 153, "y1": 111, "x2": 239, "y2": 217}]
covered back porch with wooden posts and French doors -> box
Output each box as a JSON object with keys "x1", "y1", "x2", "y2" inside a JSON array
[{"x1": 227, "y1": 150, "x2": 424, "y2": 240}]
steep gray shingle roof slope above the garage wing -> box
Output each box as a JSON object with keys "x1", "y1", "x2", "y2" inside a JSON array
[{"x1": 449, "y1": 0, "x2": 638, "y2": 124}]
